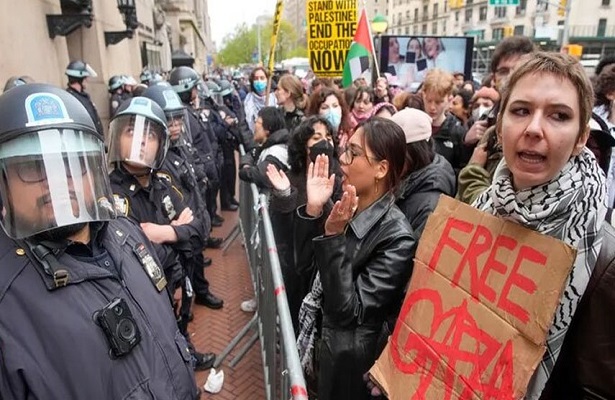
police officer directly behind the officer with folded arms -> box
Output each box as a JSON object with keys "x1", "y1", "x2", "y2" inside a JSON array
[{"x1": 143, "y1": 85, "x2": 224, "y2": 309}]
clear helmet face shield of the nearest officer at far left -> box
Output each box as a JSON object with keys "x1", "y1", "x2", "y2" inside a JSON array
[{"x1": 0, "y1": 129, "x2": 115, "y2": 239}]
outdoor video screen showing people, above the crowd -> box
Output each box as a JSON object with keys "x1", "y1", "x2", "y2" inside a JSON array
[{"x1": 380, "y1": 36, "x2": 474, "y2": 90}]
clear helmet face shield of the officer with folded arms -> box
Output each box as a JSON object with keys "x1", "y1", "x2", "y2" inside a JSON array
[{"x1": 109, "y1": 115, "x2": 168, "y2": 170}]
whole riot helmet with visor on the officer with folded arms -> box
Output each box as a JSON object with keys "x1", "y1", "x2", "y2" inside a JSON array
[{"x1": 108, "y1": 97, "x2": 169, "y2": 173}]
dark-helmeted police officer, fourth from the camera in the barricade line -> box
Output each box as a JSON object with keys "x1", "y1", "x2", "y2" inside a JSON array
[{"x1": 169, "y1": 66, "x2": 224, "y2": 242}]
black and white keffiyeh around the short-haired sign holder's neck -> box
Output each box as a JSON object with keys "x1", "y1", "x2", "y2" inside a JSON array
[{"x1": 473, "y1": 149, "x2": 607, "y2": 400}]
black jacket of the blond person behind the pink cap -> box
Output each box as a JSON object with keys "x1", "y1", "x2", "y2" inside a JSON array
[{"x1": 431, "y1": 114, "x2": 471, "y2": 176}]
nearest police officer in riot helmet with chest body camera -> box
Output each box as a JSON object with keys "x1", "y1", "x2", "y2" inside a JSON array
[{"x1": 0, "y1": 83, "x2": 198, "y2": 400}]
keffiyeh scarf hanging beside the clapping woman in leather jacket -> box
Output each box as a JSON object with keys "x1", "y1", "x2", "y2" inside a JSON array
[{"x1": 297, "y1": 272, "x2": 322, "y2": 377}]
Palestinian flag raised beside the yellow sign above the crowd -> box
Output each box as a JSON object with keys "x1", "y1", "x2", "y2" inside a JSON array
[{"x1": 342, "y1": 9, "x2": 374, "y2": 87}]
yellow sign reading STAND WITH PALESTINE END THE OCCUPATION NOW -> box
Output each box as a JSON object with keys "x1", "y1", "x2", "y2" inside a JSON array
[{"x1": 306, "y1": 0, "x2": 357, "y2": 78}]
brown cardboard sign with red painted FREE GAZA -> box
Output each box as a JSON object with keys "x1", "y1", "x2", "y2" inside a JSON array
[{"x1": 370, "y1": 196, "x2": 576, "y2": 400}]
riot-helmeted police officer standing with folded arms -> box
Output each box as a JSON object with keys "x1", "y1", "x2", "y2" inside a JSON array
[{"x1": 108, "y1": 97, "x2": 215, "y2": 370}]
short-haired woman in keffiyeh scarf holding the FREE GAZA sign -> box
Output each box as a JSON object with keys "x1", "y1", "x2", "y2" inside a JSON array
[{"x1": 474, "y1": 53, "x2": 615, "y2": 399}]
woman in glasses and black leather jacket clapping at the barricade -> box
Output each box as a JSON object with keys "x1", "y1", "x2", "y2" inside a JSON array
[{"x1": 295, "y1": 117, "x2": 416, "y2": 400}]
